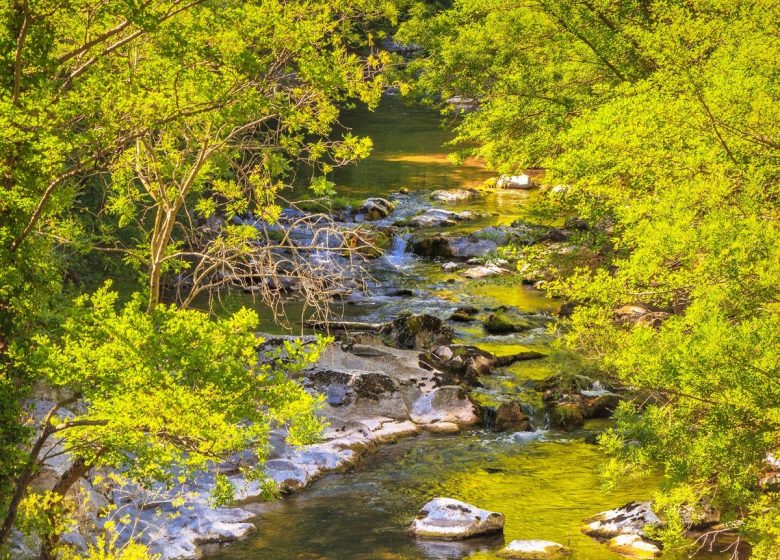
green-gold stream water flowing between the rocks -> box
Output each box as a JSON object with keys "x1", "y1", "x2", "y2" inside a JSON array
[{"x1": 210, "y1": 98, "x2": 728, "y2": 560}]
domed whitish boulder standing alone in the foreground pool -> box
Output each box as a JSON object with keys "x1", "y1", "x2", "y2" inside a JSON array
[{"x1": 409, "y1": 498, "x2": 504, "y2": 540}]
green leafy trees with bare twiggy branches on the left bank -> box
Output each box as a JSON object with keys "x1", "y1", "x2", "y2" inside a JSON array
[{"x1": 0, "y1": 0, "x2": 395, "y2": 558}]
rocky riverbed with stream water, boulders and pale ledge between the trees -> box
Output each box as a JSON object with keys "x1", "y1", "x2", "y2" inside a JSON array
[{"x1": 17, "y1": 96, "x2": 740, "y2": 560}]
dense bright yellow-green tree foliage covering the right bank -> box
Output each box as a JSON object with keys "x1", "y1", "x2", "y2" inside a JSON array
[{"x1": 401, "y1": 0, "x2": 780, "y2": 559}]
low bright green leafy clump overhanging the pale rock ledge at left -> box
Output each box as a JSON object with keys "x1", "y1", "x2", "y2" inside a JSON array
[{"x1": 25, "y1": 282, "x2": 321, "y2": 483}]
